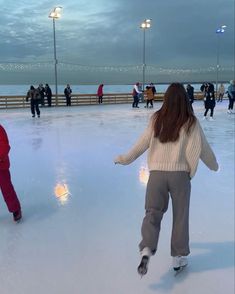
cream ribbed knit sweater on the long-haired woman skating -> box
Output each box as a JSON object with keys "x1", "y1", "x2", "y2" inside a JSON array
[{"x1": 114, "y1": 120, "x2": 218, "y2": 178}]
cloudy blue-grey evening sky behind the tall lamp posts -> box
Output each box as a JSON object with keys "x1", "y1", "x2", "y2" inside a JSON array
[{"x1": 0, "y1": 0, "x2": 235, "y2": 84}]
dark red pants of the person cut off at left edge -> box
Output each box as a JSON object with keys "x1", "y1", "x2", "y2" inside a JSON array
[{"x1": 0, "y1": 169, "x2": 20, "y2": 212}]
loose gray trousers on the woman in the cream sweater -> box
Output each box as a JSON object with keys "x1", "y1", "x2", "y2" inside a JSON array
[{"x1": 139, "y1": 171, "x2": 191, "y2": 256}]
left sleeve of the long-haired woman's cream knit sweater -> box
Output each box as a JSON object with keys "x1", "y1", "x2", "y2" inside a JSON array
[{"x1": 114, "y1": 121, "x2": 153, "y2": 165}]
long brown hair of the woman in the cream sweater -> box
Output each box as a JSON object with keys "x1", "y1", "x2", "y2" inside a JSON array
[{"x1": 153, "y1": 83, "x2": 196, "y2": 143}]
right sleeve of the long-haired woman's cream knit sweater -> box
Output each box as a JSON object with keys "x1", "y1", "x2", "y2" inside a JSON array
[{"x1": 198, "y1": 124, "x2": 219, "y2": 171}]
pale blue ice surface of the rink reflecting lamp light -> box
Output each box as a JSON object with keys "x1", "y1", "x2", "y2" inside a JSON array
[{"x1": 0, "y1": 101, "x2": 235, "y2": 294}]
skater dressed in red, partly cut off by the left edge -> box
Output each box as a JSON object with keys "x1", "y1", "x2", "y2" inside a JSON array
[{"x1": 0, "y1": 125, "x2": 22, "y2": 222}]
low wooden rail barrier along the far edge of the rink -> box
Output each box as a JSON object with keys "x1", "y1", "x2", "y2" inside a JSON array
[{"x1": 0, "y1": 93, "x2": 206, "y2": 109}]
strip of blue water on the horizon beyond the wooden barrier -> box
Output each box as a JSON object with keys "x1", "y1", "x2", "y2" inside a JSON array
[{"x1": 0, "y1": 84, "x2": 228, "y2": 96}]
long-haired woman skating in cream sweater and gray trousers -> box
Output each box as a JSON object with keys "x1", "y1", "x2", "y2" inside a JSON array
[{"x1": 114, "y1": 83, "x2": 218, "y2": 275}]
